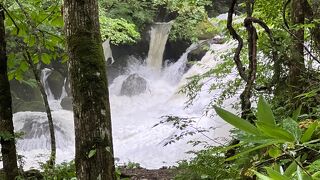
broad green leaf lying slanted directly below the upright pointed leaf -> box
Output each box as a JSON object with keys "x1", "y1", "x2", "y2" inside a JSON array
[{"x1": 256, "y1": 122, "x2": 295, "y2": 142}]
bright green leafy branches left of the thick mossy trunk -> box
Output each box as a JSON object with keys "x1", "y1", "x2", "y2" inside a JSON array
[{"x1": 3, "y1": 0, "x2": 65, "y2": 81}]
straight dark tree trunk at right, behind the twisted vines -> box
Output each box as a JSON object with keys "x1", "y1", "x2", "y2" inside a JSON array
[{"x1": 289, "y1": 0, "x2": 306, "y2": 90}]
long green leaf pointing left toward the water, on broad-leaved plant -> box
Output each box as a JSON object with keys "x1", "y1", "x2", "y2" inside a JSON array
[{"x1": 214, "y1": 106, "x2": 260, "y2": 135}]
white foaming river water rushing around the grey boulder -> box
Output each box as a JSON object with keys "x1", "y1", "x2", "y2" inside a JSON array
[{"x1": 14, "y1": 22, "x2": 234, "y2": 169}]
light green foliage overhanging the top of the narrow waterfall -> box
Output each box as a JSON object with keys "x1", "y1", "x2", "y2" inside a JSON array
[{"x1": 100, "y1": 0, "x2": 213, "y2": 44}]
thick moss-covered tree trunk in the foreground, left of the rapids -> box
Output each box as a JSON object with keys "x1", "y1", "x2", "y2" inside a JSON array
[{"x1": 63, "y1": 0, "x2": 115, "y2": 180}]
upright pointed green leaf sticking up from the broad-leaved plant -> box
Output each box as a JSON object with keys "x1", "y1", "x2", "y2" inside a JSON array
[{"x1": 257, "y1": 96, "x2": 276, "y2": 126}]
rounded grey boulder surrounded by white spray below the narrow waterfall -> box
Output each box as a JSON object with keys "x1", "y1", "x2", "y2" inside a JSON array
[{"x1": 120, "y1": 73, "x2": 147, "y2": 96}]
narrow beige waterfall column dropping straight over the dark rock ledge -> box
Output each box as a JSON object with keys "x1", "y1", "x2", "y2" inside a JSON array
[{"x1": 146, "y1": 22, "x2": 172, "y2": 71}]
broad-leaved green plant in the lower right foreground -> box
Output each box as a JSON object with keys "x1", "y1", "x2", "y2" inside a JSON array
[{"x1": 215, "y1": 97, "x2": 320, "y2": 179}]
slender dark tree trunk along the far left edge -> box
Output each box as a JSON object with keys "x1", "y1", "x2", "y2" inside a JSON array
[{"x1": 0, "y1": 6, "x2": 18, "y2": 180}]
